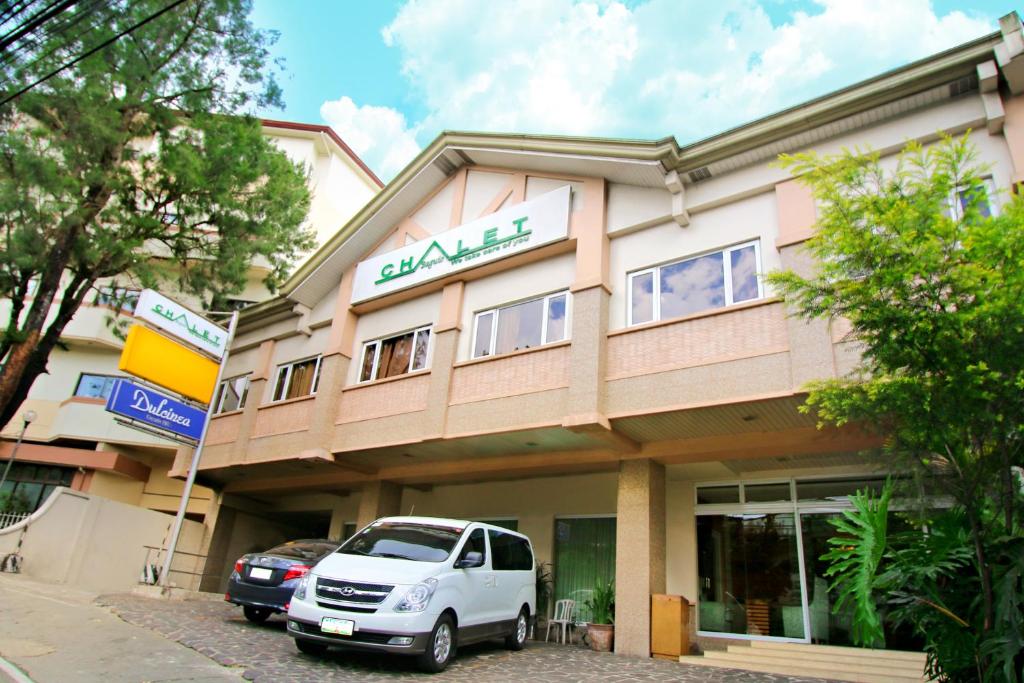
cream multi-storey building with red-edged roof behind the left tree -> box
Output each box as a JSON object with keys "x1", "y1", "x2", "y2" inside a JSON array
[{"x1": 0, "y1": 121, "x2": 383, "y2": 519}]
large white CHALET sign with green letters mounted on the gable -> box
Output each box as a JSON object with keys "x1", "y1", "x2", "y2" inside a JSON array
[{"x1": 352, "y1": 185, "x2": 571, "y2": 303}]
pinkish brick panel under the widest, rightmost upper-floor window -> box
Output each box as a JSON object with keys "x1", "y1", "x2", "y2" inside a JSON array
[{"x1": 608, "y1": 302, "x2": 788, "y2": 380}]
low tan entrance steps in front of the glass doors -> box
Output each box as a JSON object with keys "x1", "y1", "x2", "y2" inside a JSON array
[{"x1": 679, "y1": 640, "x2": 929, "y2": 683}]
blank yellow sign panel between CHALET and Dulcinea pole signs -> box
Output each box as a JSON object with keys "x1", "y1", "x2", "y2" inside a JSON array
[{"x1": 118, "y1": 325, "x2": 218, "y2": 403}]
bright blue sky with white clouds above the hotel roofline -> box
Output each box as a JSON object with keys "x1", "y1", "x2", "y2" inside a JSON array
[{"x1": 252, "y1": 0, "x2": 1014, "y2": 180}]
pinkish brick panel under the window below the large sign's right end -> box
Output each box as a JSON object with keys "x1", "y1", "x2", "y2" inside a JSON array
[{"x1": 450, "y1": 345, "x2": 569, "y2": 405}]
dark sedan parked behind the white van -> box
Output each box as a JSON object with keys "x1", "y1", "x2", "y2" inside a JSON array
[{"x1": 224, "y1": 539, "x2": 341, "y2": 624}]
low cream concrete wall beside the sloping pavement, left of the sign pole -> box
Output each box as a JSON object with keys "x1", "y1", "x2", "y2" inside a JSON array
[{"x1": 0, "y1": 487, "x2": 203, "y2": 592}]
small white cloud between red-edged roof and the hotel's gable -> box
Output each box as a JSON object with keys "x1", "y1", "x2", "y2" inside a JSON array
[{"x1": 321, "y1": 96, "x2": 420, "y2": 180}]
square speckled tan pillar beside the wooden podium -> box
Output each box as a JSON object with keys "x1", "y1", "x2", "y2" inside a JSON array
[{"x1": 615, "y1": 460, "x2": 665, "y2": 657}]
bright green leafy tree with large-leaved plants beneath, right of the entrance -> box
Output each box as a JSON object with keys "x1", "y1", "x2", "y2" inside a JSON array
[{"x1": 770, "y1": 135, "x2": 1024, "y2": 680}]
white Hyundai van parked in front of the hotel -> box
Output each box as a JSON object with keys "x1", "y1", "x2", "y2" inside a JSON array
[{"x1": 288, "y1": 517, "x2": 537, "y2": 672}]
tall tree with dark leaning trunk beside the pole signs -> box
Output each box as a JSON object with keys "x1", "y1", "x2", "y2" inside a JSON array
[{"x1": 0, "y1": 0, "x2": 312, "y2": 425}]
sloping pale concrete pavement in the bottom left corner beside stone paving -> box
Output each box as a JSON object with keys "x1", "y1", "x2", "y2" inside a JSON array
[{"x1": 0, "y1": 573, "x2": 242, "y2": 683}]
